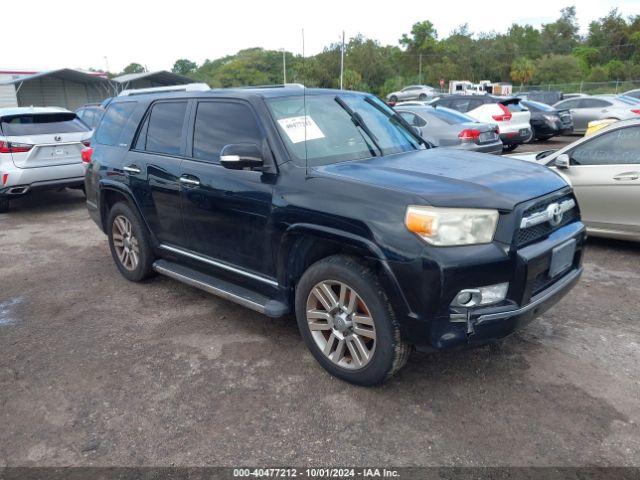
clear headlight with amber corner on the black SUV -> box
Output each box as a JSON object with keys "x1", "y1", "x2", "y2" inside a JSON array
[{"x1": 404, "y1": 205, "x2": 499, "y2": 246}]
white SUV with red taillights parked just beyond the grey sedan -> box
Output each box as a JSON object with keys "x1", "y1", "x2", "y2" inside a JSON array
[{"x1": 431, "y1": 95, "x2": 533, "y2": 151}]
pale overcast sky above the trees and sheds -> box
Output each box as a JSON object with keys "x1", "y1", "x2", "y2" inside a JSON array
[{"x1": 5, "y1": 0, "x2": 640, "y2": 72}]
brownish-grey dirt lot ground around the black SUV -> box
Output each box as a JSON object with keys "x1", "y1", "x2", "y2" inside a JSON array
[{"x1": 0, "y1": 142, "x2": 640, "y2": 466}]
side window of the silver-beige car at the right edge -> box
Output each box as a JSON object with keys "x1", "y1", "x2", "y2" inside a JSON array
[{"x1": 571, "y1": 127, "x2": 640, "y2": 165}]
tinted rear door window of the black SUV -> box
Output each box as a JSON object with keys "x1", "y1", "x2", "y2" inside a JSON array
[{"x1": 145, "y1": 102, "x2": 187, "y2": 155}]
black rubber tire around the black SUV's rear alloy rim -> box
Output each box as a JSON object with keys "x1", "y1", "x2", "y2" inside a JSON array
[{"x1": 107, "y1": 202, "x2": 155, "y2": 282}]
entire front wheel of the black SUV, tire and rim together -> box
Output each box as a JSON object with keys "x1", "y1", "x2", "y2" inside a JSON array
[{"x1": 295, "y1": 255, "x2": 411, "y2": 386}]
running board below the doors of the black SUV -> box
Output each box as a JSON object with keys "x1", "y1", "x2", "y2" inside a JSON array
[{"x1": 153, "y1": 260, "x2": 289, "y2": 317}]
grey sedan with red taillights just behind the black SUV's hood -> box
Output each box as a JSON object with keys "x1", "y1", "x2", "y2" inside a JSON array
[{"x1": 396, "y1": 104, "x2": 502, "y2": 154}]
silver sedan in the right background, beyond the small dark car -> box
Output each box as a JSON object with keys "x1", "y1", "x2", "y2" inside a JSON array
[{"x1": 554, "y1": 96, "x2": 640, "y2": 133}]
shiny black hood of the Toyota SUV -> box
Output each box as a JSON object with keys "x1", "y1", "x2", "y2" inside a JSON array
[{"x1": 314, "y1": 148, "x2": 567, "y2": 210}]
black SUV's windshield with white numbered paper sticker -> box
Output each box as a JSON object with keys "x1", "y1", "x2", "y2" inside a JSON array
[{"x1": 267, "y1": 92, "x2": 423, "y2": 166}]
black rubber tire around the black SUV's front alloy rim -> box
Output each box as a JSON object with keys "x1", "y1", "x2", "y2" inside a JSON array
[{"x1": 295, "y1": 255, "x2": 411, "y2": 386}]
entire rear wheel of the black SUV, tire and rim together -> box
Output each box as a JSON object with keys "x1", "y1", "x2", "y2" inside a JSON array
[{"x1": 107, "y1": 202, "x2": 154, "y2": 282}]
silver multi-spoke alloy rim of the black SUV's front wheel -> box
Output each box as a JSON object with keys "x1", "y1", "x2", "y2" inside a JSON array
[{"x1": 306, "y1": 280, "x2": 376, "y2": 370}]
